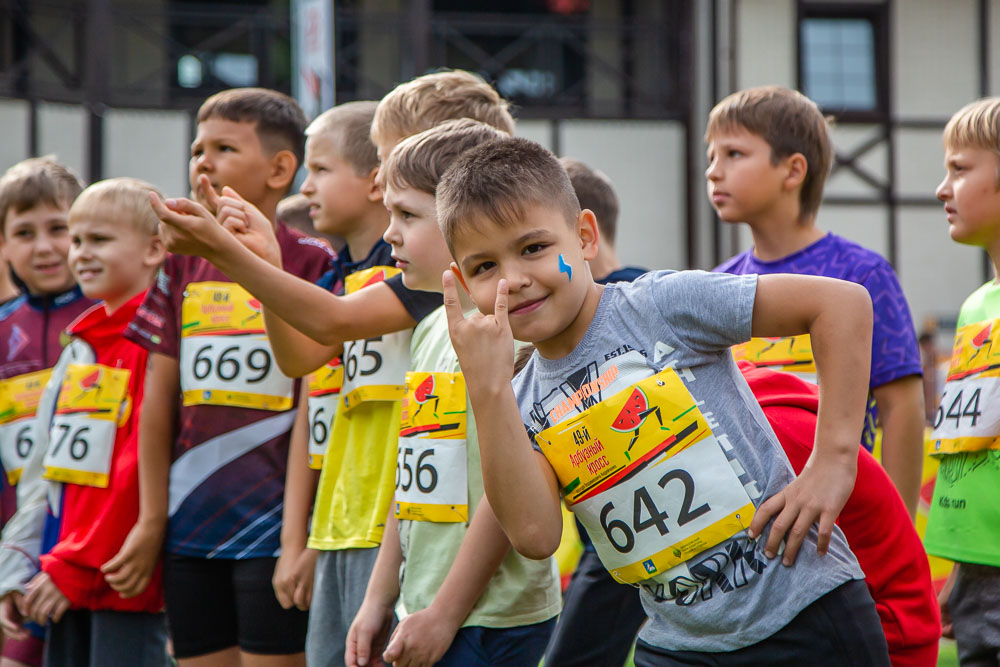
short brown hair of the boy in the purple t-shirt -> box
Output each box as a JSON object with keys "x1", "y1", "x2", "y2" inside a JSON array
[{"x1": 705, "y1": 86, "x2": 833, "y2": 219}]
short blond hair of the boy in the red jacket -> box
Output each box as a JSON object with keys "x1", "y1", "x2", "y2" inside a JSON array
[{"x1": 69, "y1": 177, "x2": 163, "y2": 236}]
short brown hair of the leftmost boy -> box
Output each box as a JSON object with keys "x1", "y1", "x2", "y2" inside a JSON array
[{"x1": 0, "y1": 155, "x2": 83, "y2": 233}]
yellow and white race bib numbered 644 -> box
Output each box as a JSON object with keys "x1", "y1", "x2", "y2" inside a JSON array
[{"x1": 929, "y1": 319, "x2": 1000, "y2": 455}]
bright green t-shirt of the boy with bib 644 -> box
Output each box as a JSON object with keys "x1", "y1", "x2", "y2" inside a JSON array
[{"x1": 924, "y1": 280, "x2": 1000, "y2": 567}]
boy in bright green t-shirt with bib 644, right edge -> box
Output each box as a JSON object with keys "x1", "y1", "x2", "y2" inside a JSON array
[{"x1": 924, "y1": 97, "x2": 1000, "y2": 665}]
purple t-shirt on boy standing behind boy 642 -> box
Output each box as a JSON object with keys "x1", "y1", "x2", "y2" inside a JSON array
[{"x1": 715, "y1": 234, "x2": 922, "y2": 450}]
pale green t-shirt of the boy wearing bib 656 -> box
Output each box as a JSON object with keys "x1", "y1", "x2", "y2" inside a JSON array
[{"x1": 399, "y1": 306, "x2": 562, "y2": 628}]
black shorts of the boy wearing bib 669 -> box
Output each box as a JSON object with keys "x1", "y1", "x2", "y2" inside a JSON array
[{"x1": 163, "y1": 554, "x2": 308, "y2": 658}]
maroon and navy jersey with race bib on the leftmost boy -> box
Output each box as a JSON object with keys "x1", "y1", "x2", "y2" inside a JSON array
[{"x1": 0, "y1": 286, "x2": 94, "y2": 523}]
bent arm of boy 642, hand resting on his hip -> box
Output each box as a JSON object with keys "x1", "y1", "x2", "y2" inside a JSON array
[{"x1": 750, "y1": 274, "x2": 872, "y2": 565}]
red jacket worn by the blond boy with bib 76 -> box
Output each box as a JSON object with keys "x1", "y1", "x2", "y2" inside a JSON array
[{"x1": 41, "y1": 292, "x2": 163, "y2": 612}]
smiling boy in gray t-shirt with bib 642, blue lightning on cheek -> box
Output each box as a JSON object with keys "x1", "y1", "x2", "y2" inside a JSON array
[{"x1": 437, "y1": 139, "x2": 888, "y2": 665}]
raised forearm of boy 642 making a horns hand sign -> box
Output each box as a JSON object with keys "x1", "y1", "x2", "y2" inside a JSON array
[{"x1": 442, "y1": 271, "x2": 562, "y2": 559}]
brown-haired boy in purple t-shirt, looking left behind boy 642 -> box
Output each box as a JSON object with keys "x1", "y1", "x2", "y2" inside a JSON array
[{"x1": 705, "y1": 86, "x2": 924, "y2": 516}]
